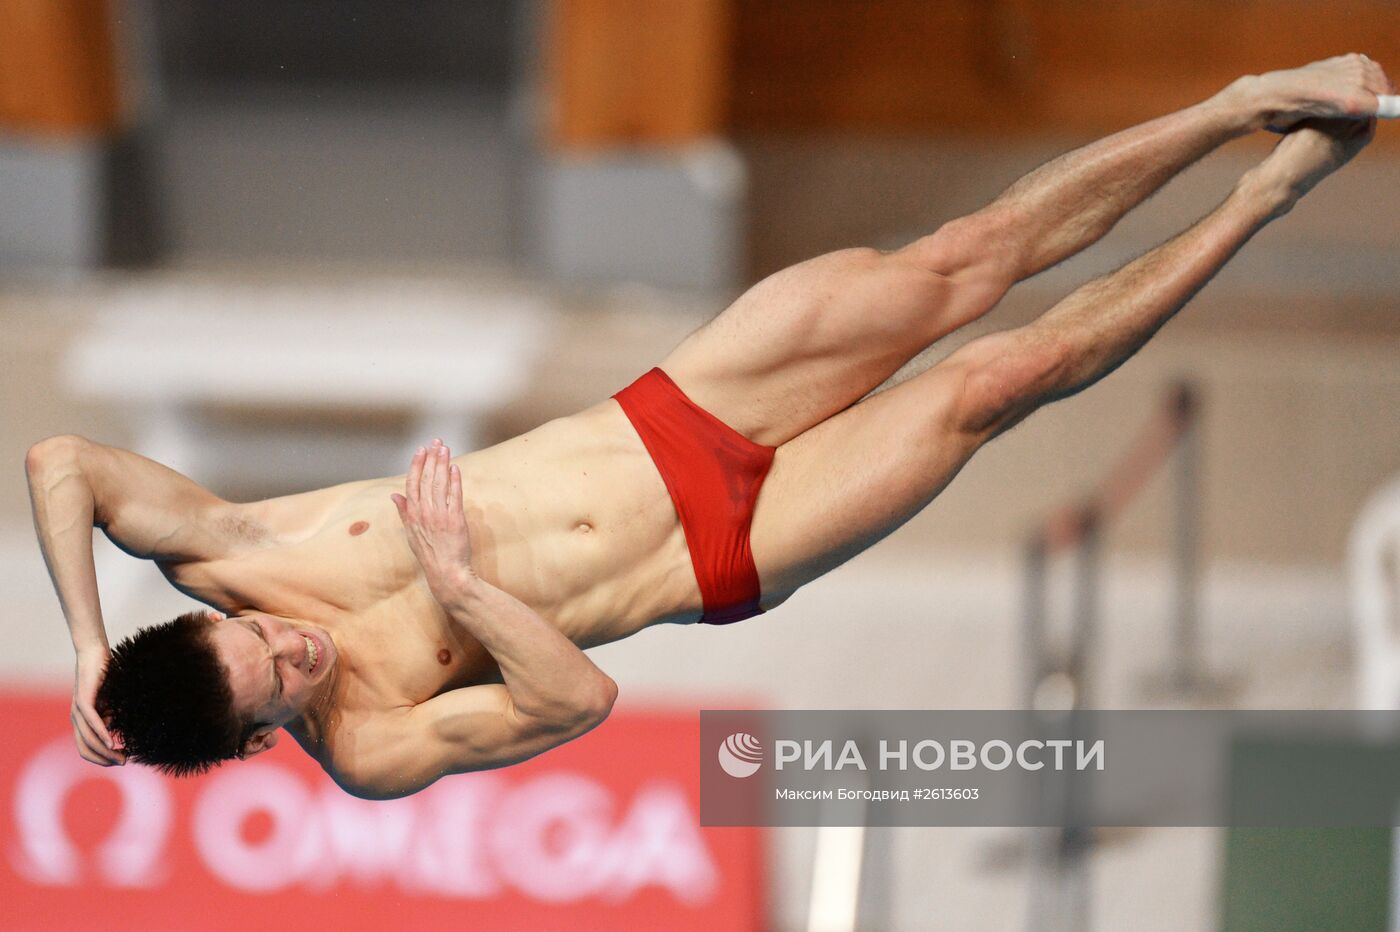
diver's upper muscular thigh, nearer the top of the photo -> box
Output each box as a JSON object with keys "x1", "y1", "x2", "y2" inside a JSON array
[{"x1": 661, "y1": 249, "x2": 949, "y2": 446}]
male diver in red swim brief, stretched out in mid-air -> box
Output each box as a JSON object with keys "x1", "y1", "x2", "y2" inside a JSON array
[{"x1": 27, "y1": 55, "x2": 1394, "y2": 798}]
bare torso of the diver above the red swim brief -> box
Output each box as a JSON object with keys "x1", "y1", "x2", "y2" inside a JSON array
[{"x1": 168, "y1": 399, "x2": 711, "y2": 764}]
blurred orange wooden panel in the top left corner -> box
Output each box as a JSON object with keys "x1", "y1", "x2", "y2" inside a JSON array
[{"x1": 0, "y1": 0, "x2": 119, "y2": 133}]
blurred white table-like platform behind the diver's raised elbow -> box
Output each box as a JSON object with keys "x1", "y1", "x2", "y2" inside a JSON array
[{"x1": 63, "y1": 277, "x2": 552, "y2": 481}]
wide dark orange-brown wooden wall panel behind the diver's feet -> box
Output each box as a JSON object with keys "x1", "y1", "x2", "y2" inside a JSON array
[{"x1": 729, "y1": 0, "x2": 1400, "y2": 136}]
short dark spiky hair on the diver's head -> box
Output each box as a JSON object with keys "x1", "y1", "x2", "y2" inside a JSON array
[{"x1": 95, "y1": 612, "x2": 258, "y2": 777}]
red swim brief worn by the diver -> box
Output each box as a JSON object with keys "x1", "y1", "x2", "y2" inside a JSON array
[{"x1": 613, "y1": 368, "x2": 777, "y2": 624}]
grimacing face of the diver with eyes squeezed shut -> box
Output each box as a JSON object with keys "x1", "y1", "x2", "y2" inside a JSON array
[{"x1": 210, "y1": 612, "x2": 339, "y2": 726}]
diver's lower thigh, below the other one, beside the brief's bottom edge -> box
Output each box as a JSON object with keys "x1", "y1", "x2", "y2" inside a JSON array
[{"x1": 750, "y1": 367, "x2": 980, "y2": 606}]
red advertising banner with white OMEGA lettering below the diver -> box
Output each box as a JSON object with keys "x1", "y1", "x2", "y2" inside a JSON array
[{"x1": 0, "y1": 690, "x2": 764, "y2": 932}]
